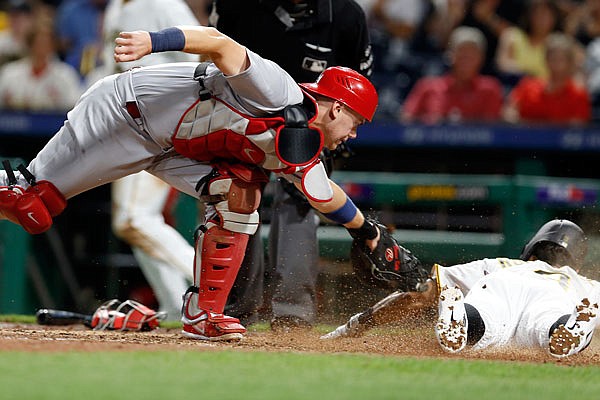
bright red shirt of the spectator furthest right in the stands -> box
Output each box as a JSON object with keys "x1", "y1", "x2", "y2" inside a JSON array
[{"x1": 509, "y1": 77, "x2": 592, "y2": 123}]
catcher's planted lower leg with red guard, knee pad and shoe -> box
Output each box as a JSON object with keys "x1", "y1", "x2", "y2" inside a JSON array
[{"x1": 182, "y1": 163, "x2": 268, "y2": 340}]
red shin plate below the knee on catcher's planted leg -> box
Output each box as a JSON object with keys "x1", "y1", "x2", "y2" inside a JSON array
[{"x1": 189, "y1": 223, "x2": 249, "y2": 320}]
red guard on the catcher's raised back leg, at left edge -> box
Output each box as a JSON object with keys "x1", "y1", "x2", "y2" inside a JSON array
[{"x1": 0, "y1": 162, "x2": 67, "y2": 234}]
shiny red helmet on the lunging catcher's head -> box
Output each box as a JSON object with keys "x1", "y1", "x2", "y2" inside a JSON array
[{"x1": 300, "y1": 67, "x2": 377, "y2": 121}]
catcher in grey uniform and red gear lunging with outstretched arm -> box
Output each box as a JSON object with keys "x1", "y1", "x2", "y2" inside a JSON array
[{"x1": 0, "y1": 26, "x2": 379, "y2": 340}]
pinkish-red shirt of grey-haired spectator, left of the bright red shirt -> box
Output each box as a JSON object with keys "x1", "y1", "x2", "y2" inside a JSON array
[{"x1": 403, "y1": 75, "x2": 503, "y2": 124}]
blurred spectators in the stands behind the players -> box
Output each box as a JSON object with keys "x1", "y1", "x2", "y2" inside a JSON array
[{"x1": 0, "y1": 0, "x2": 600, "y2": 125}]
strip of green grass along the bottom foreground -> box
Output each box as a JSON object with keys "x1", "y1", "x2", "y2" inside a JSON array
[{"x1": 0, "y1": 349, "x2": 600, "y2": 400}]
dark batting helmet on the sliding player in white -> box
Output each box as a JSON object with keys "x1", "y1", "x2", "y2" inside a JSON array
[{"x1": 520, "y1": 219, "x2": 587, "y2": 268}]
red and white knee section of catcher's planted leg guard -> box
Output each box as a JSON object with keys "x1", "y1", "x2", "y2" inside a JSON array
[{"x1": 201, "y1": 164, "x2": 268, "y2": 235}]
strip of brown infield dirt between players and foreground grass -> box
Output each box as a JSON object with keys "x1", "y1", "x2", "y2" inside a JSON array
[{"x1": 0, "y1": 323, "x2": 600, "y2": 365}]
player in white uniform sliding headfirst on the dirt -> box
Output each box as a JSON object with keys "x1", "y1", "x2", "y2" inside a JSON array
[{"x1": 322, "y1": 220, "x2": 600, "y2": 357}]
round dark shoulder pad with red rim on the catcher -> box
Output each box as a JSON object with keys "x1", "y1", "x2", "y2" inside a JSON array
[{"x1": 275, "y1": 105, "x2": 324, "y2": 167}]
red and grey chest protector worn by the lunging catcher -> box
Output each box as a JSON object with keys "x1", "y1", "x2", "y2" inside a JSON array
[{"x1": 172, "y1": 97, "x2": 323, "y2": 173}]
